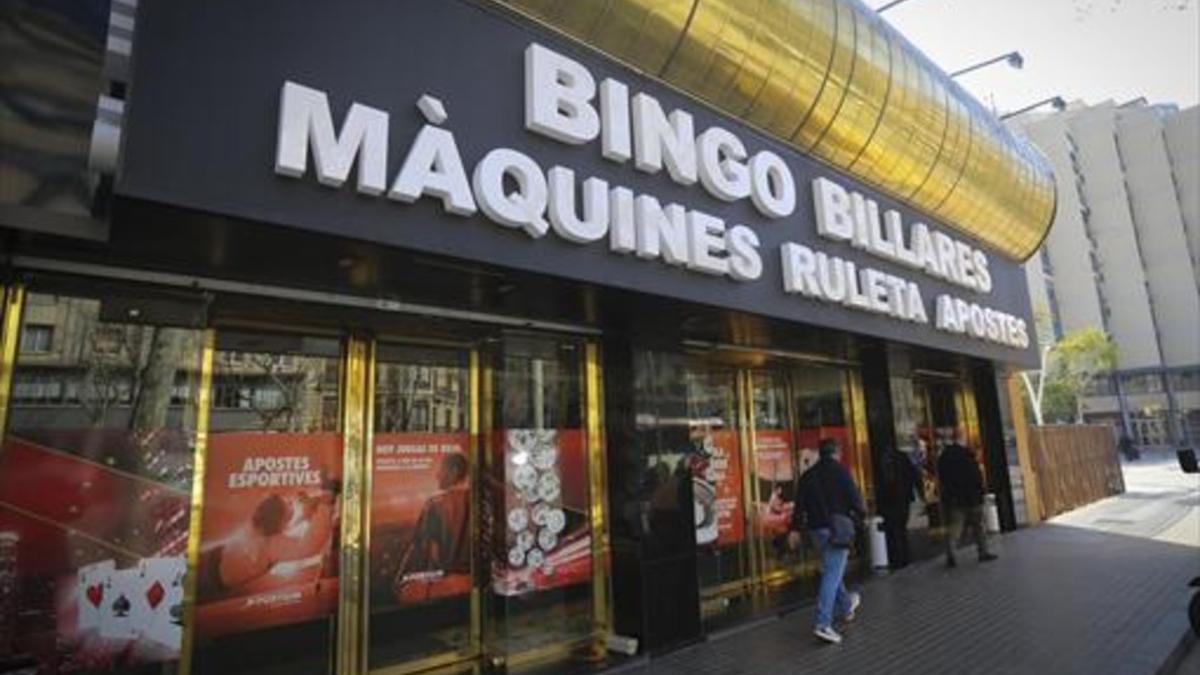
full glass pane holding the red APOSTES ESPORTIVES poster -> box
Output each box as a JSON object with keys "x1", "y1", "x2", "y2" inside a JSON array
[{"x1": 194, "y1": 331, "x2": 342, "y2": 675}]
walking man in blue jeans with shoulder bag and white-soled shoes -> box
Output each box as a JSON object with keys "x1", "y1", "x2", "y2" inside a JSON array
[{"x1": 787, "y1": 438, "x2": 865, "y2": 644}]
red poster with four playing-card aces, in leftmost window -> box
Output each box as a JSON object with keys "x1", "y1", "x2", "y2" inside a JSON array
[{"x1": 0, "y1": 430, "x2": 191, "y2": 674}]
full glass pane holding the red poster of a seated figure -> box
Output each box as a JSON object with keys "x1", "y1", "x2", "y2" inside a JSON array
[{"x1": 367, "y1": 345, "x2": 474, "y2": 669}]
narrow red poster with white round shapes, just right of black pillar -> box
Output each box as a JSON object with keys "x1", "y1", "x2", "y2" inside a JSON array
[{"x1": 689, "y1": 430, "x2": 745, "y2": 546}]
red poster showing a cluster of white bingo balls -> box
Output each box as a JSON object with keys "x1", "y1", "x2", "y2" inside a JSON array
[{"x1": 488, "y1": 429, "x2": 592, "y2": 596}]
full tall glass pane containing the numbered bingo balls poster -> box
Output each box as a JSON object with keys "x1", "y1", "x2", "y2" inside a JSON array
[{"x1": 485, "y1": 334, "x2": 594, "y2": 655}]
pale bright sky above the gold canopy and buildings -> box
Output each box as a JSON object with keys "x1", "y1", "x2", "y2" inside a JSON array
[{"x1": 883, "y1": 0, "x2": 1200, "y2": 113}]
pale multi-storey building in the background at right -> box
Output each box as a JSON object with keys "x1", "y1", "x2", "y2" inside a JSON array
[{"x1": 1012, "y1": 100, "x2": 1200, "y2": 446}]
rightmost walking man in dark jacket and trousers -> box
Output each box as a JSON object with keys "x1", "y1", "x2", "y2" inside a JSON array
[{"x1": 937, "y1": 434, "x2": 996, "y2": 567}]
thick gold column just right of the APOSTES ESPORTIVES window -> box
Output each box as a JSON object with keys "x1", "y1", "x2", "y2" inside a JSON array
[{"x1": 334, "y1": 335, "x2": 374, "y2": 675}]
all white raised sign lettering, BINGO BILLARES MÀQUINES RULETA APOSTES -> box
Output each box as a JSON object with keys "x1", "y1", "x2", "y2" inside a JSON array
[{"x1": 275, "y1": 44, "x2": 1028, "y2": 348}]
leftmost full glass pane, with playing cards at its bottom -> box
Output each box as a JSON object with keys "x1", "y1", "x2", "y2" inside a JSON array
[{"x1": 0, "y1": 293, "x2": 202, "y2": 674}]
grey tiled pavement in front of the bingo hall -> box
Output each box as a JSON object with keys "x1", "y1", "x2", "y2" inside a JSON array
[{"x1": 620, "y1": 454, "x2": 1200, "y2": 675}]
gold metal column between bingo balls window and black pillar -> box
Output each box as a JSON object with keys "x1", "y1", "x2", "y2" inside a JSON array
[{"x1": 583, "y1": 340, "x2": 612, "y2": 653}]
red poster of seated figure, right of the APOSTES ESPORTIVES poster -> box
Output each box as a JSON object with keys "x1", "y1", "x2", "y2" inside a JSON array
[{"x1": 371, "y1": 434, "x2": 472, "y2": 607}]
